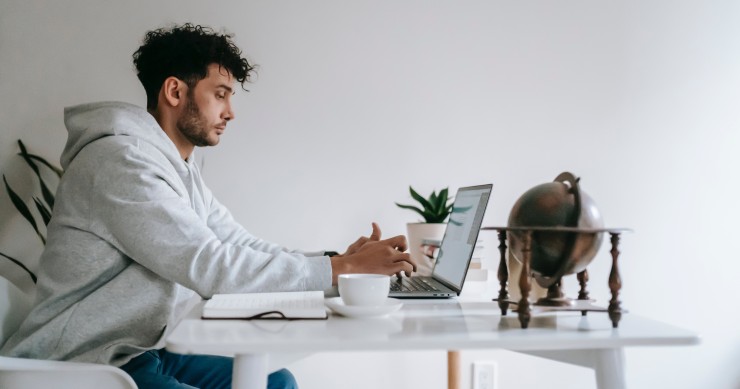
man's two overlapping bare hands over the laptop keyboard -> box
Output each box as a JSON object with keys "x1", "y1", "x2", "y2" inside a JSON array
[{"x1": 331, "y1": 227, "x2": 416, "y2": 285}]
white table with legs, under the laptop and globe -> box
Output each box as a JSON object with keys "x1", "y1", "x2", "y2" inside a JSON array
[{"x1": 166, "y1": 300, "x2": 699, "y2": 389}]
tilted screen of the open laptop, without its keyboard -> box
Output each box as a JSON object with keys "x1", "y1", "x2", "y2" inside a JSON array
[{"x1": 432, "y1": 184, "x2": 492, "y2": 290}]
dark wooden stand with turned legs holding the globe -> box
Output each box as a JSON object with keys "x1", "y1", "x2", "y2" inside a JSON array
[{"x1": 481, "y1": 227, "x2": 630, "y2": 328}]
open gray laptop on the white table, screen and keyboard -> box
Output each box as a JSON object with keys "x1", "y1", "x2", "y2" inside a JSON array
[{"x1": 388, "y1": 184, "x2": 493, "y2": 298}]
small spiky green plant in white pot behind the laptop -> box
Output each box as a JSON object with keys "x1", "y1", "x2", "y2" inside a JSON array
[{"x1": 396, "y1": 186, "x2": 452, "y2": 275}]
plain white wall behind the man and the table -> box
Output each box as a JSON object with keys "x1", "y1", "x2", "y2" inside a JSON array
[{"x1": 0, "y1": 0, "x2": 740, "y2": 389}]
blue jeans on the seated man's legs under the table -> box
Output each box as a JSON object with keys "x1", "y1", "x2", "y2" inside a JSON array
[{"x1": 121, "y1": 349, "x2": 298, "y2": 389}]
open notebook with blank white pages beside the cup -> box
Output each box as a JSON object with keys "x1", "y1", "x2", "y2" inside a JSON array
[{"x1": 202, "y1": 291, "x2": 328, "y2": 320}]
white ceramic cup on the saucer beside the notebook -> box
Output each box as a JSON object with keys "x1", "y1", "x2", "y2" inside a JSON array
[{"x1": 338, "y1": 274, "x2": 391, "y2": 306}]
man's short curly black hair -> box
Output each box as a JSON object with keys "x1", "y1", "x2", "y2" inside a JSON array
[{"x1": 133, "y1": 23, "x2": 254, "y2": 109}]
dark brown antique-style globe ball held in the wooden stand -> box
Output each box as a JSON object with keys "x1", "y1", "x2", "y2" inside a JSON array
[{"x1": 508, "y1": 172, "x2": 604, "y2": 288}]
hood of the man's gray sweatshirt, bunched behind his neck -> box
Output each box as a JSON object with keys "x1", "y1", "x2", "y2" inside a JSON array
[{"x1": 60, "y1": 101, "x2": 187, "y2": 170}]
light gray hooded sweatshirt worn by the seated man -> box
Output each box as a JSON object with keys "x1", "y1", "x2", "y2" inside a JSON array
[{"x1": 0, "y1": 102, "x2": 331, "y2": 366}]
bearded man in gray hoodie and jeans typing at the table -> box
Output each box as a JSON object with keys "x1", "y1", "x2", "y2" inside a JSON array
[{"x1": 2, "y1": 24, "x2": 415, "y2": 389}]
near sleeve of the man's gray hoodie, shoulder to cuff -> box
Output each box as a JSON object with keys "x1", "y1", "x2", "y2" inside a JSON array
[{"x1": 84, "y1": 144, "x2": 331, "y2": 298}]
